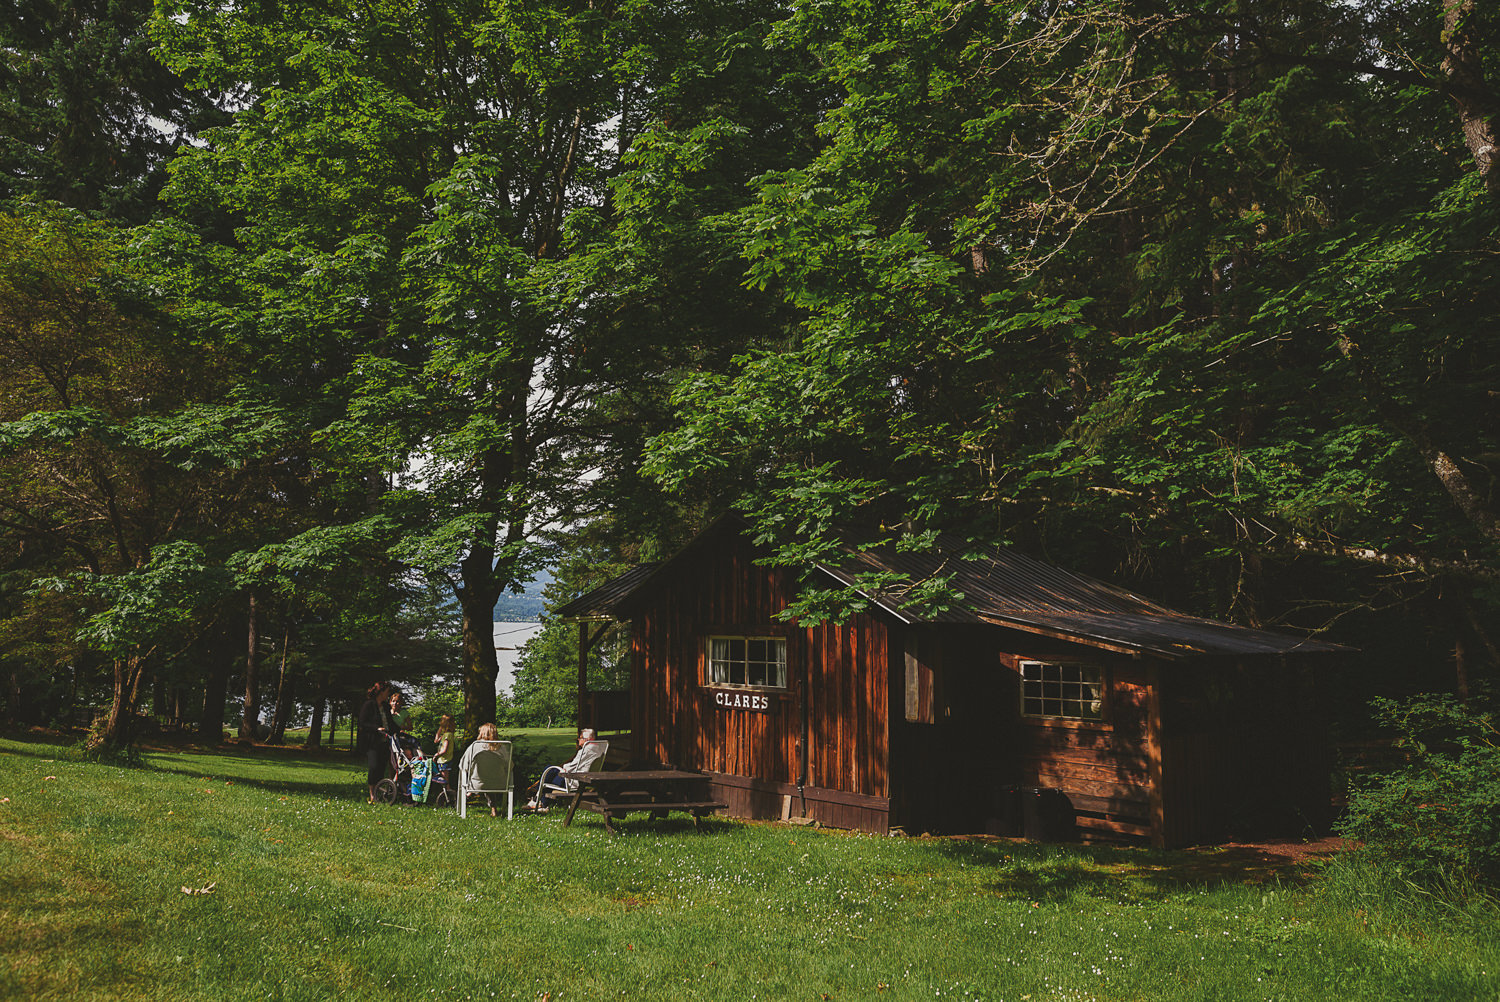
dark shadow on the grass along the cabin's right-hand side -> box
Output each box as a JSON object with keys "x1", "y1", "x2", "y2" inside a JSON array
[{"x1": 932, "y1": 837, "x2": 1343, "y2": 900}]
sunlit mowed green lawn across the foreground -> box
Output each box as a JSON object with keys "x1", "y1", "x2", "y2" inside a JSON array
[{"x1": 0, "y1": 741, "x2": 1500, "y2": 1002}]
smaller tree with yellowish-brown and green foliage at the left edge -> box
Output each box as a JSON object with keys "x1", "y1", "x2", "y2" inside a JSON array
[{"x1": 0, "y1": 209, "x2": 287, "y2": 747}]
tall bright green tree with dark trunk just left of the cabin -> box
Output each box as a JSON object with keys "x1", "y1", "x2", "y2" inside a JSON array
[{"x1": 158, "y1": 0, "x2": 822, "y2": 732}]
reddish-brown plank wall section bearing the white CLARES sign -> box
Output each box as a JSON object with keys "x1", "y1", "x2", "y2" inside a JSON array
[{"x1": 632, "y1": 533, "x2": 890, "y2": 827}]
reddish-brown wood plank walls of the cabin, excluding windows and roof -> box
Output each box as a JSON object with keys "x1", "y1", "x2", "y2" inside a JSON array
[{"x1": 630, "y1": 531, "x2": 1328, "y2": 846}]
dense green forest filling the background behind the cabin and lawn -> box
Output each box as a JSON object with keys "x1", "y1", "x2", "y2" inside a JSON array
[{"x1": 0, "y1": 0, "x2": 1500, "y2": 749}]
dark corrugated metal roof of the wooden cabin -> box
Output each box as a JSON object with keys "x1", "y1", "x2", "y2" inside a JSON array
[{"x1": 557, "y1": 519, "x2": 1352, "y2": 659}]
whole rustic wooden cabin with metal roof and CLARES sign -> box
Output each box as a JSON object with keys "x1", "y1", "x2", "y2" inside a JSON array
[{"x1": 558, "y1": 518, "x2": 1347, "y2": 846}]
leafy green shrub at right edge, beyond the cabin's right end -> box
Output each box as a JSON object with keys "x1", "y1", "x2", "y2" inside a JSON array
[{"x1": 1338, "y1": 695, "x2": 1500, "y2": 887}]
